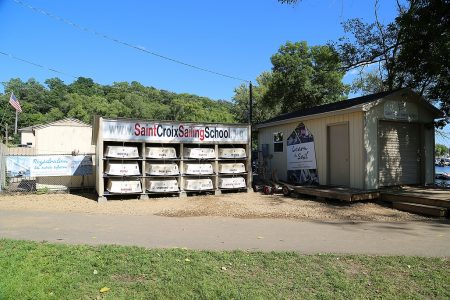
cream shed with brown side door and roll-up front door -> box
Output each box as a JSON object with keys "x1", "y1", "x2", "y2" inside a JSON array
[{"x1": 256, "y1": 89, "x2": 441, "y2": 189}]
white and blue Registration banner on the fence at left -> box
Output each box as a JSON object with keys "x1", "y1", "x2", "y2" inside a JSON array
[{"x1": 6, "y1": 155, "x2": 93, "y2": 177}]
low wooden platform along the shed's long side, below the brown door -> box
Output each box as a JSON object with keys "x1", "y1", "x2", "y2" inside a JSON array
[{"x1": 292, "y1": 185, "x2": 380, "y2": 202}]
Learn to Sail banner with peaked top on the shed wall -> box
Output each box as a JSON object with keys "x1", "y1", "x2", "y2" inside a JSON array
[{"x1": 287, "y1": 123, "x2": 319, "y2": 185}]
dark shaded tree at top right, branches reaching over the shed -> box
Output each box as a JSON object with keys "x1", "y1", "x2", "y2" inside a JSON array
[{"x1": 334, "y1": 0, "x2": 450, "y2": 126}]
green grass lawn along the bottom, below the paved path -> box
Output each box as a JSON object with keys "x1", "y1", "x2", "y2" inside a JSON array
[{"x1": 0, "y1": 239, "x2": 450, "y2": 299}]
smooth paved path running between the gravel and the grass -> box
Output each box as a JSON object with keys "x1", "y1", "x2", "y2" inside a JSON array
[{"x1": 0, "y1": 211, "x2": 450, "y2": 257}]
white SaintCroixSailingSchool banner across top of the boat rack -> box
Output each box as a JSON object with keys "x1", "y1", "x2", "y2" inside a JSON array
[{"x1": 102, "y1": 120, "x2": 249, "y2": 143}]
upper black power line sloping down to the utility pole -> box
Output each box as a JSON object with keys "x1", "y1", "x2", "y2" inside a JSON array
[{"x1": 13, "y1": 0, "x2": 250, "y2": 82}]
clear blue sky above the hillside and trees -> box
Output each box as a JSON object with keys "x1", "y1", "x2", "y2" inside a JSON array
[{"x1": 0, "y1": 0, "x2": 446, "y2": 141}]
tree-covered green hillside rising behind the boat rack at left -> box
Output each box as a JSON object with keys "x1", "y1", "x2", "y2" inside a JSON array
[{"x1": 0, "y1": 77, "x2": 236, "y2": 139}]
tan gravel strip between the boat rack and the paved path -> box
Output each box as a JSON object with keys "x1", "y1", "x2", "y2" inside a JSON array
[{"x1": 0, "y1": 192, "x2": 428, "y2": 222}]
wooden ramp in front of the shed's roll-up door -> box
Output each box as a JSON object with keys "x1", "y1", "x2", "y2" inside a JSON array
[{"x1": 380, "y1": 186, "x2": 450, "y2": 217}]
